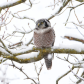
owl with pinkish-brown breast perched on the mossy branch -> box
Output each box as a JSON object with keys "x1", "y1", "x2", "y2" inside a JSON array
[{"x1": 33, "y1": 19, "x2": 55, "y2": 70}]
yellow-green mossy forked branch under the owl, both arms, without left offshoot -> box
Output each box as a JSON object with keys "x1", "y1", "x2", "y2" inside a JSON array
[{"x1": 2, "y1": 48, "x2": 84, "y2": 63}]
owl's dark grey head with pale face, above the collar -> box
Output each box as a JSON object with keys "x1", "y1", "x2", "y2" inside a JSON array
[{"x1": 36, "y1": 19, "x2": 51, "y2": 29}]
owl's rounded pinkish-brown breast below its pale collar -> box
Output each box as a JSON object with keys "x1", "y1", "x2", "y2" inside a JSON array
[{"x1": 34, "y1": 30, "x2": 55, "y2": 47}]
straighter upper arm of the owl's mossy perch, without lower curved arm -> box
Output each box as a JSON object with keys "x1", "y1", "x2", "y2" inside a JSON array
[{"x1": 13, "y1": 48, "x2": 84, "y2": 56}]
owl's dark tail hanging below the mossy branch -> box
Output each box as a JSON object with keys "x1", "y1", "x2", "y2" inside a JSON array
[{"x1": 44, "y1": 54, "x2": 54, "y2": 70}]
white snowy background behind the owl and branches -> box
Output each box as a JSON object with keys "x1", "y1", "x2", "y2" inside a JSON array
[{"x1": 0, "y1": 0, "x2": 84, "y2": 84}]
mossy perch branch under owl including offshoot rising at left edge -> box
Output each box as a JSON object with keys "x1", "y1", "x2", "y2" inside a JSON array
[{"x1": 0, "y1": 39, "x2": 84, "y2": 63}]
